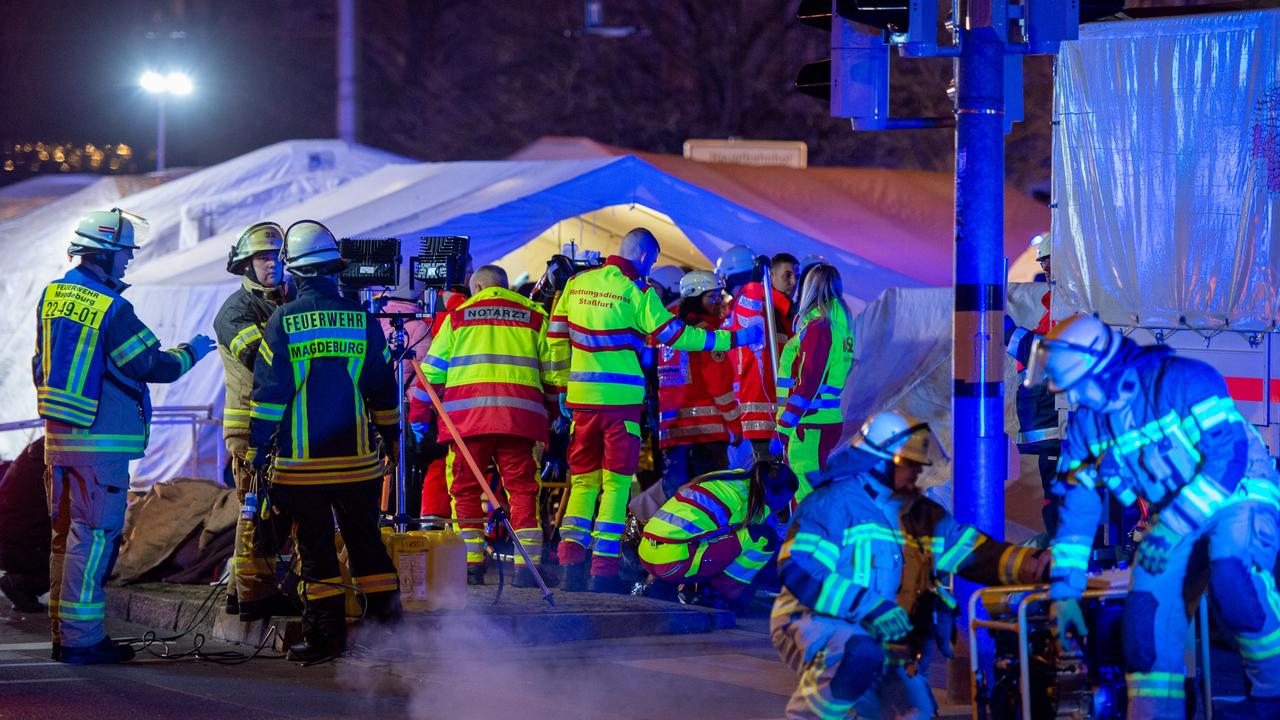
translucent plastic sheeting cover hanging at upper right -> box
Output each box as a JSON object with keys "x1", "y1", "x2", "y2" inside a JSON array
[{"x1": 1053, "y1": 10, "x2": 1280, "y2": 329}]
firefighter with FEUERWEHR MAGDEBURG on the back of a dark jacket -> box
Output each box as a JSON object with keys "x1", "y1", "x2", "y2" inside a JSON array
[{"x1": 247, "y1": 220, "x2": 399, "y2": 662}]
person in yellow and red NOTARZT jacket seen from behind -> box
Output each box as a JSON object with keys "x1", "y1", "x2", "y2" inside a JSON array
[{"x1": 422, "y1": 265, "x2": 556, "y2": 588}]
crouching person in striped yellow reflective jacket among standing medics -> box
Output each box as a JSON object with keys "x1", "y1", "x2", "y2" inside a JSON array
[{"x1": 640, "y1": 460, "x2": 799, "y2": 607}]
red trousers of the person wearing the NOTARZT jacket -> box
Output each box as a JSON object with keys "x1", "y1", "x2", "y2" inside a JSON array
[{"x1": 448, "y1": 436, "x2": 541, "y2": 565}]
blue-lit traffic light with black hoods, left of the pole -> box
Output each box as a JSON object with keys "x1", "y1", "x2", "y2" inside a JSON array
[{"x1": 796, "y1": 0, "x2": 888, "y2": 129}]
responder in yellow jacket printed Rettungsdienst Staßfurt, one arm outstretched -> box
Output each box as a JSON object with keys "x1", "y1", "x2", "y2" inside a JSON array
[{"x1": 547, "y1": 228, "x2": 764, "y2": 592}]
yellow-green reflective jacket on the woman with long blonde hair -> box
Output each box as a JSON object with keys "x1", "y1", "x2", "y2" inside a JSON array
[{"x1": 778, "y1": 304, "x2": 854, "y2": 436}]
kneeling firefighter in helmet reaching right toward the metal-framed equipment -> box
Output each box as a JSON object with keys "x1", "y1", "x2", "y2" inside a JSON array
[{"x1": 769, "y1": 413, "x2": 1050, "y2": 720}]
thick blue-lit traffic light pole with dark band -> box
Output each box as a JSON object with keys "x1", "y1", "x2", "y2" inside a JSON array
[{"x1": 951, "y1": 12, "x2": 1009, "y2": 538}]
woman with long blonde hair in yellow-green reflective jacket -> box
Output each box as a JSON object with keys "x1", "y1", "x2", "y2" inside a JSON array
[{"x1": 772, "y1": 263, "x2": 854, "y2": 502}]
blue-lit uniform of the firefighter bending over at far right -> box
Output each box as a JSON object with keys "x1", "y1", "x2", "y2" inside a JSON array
[{"x1": 1051, "y1": 338, "x2": 1280, "y2": 719}]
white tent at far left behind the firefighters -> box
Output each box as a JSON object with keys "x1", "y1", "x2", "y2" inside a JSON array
[{"x1": 0, "y1": 140, "x2": 406, "y2": 478}]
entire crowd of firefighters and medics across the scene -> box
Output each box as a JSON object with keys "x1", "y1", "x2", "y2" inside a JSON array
[{"x1": 10, "y1": 209, "x2": 1280, "y2": 717}]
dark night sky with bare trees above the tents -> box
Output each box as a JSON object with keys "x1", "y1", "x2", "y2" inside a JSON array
[{"x1": 0, "y1": 0, "x2": 1239, "y2": 192}]
